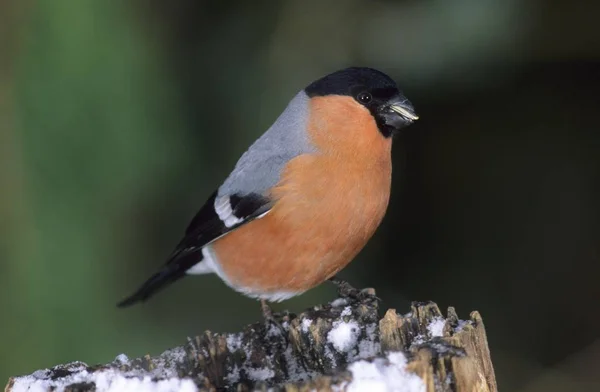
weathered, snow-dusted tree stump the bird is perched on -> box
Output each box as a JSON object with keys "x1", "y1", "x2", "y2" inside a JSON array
[{"x1": 5, "y1": 289, "x2": 497, "y2": 392}]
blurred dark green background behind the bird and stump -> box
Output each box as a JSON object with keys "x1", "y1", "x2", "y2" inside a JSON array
[{"x1": 0, "y1": 0, "x2": 600, "y2": 392}]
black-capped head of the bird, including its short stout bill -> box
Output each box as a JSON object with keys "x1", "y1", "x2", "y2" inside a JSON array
[{"x1": 304, "y1": 67, "x2": 419, "y2": 137}]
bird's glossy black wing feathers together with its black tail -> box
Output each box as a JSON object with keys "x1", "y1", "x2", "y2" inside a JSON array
[{"x1": 117, "y1": 192, "x2": 272, "y2": 307}]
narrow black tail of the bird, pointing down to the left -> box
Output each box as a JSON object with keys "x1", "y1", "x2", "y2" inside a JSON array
[{"x1": 117, "y1": 252, "x2": 202, "y2": 308}]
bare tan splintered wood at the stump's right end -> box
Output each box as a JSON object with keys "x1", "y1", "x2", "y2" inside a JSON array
[{"x1": 379, "y1": 302, "x2": 497, "y2": 392}]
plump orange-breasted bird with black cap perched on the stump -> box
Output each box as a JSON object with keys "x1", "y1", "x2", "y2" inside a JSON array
[{"x1": 117, "y1": 67, "x2": 419, "y2": 318}]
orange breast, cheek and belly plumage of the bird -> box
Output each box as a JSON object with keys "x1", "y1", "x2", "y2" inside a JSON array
[{"x1": 213, "y1": 96, "x2": 391, "y2": 294}]
